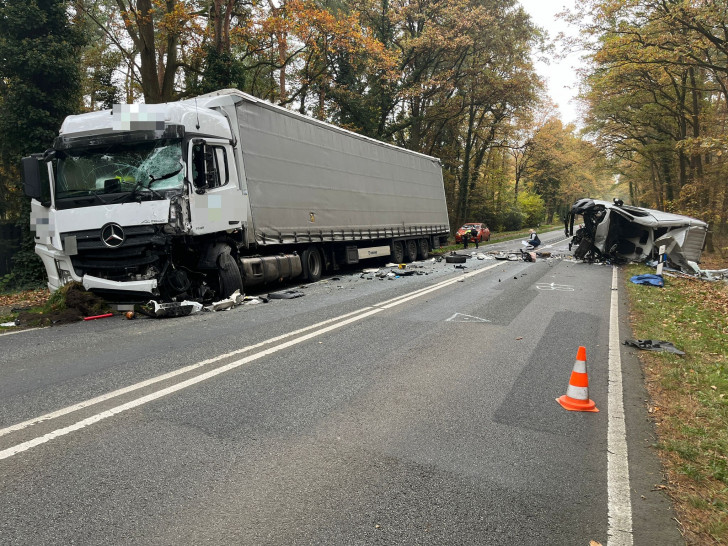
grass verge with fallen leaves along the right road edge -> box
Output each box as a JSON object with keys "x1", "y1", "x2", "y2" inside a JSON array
[{"x1": 627, "y1": 265, "x2": 728, "y2": 544}]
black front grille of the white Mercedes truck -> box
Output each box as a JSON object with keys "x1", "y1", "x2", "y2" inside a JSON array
[{"x1": 66, "y1": 226, "x2": 159, "y2": 281}]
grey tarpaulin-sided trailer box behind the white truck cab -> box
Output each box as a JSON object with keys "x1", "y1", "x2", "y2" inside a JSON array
[{"x1": 198, "y1": 90, "x2": 449, "y2": 245}]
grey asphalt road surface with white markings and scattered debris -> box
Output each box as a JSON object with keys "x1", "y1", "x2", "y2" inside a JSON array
[{"x1": 0, "y1": 227, "x2": 683, "y2": 545}]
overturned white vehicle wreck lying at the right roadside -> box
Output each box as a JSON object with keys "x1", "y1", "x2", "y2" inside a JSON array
[{"x1": 565, "y1": 199, "x2": 708, "y2": 272}]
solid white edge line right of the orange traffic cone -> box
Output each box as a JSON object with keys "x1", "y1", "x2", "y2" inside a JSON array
[{"x1": 607, "y1": 267, "x2": 633, "y2": 546}]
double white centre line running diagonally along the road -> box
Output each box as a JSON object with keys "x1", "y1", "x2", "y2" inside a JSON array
[{"x1": 0, "y1": 264, "x2": 500, "y2": 460}]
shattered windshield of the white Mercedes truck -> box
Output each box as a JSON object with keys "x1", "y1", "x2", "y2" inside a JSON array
[{"x1": 56, "y1": 140, "x2": 184, "y2": 199}]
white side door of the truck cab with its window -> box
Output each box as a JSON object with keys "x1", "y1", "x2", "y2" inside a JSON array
[{"x1": 187, "y1": 138, "x2": 245, "y2": 235}]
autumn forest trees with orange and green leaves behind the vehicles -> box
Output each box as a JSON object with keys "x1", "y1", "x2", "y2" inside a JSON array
[{"x1": 0, "y1": 0, "x2": 728, "y2": 287}]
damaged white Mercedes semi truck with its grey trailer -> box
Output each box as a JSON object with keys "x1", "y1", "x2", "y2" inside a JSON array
[{"x1": 22, "y1": 89, "x2": 449, "y2": 303}]
